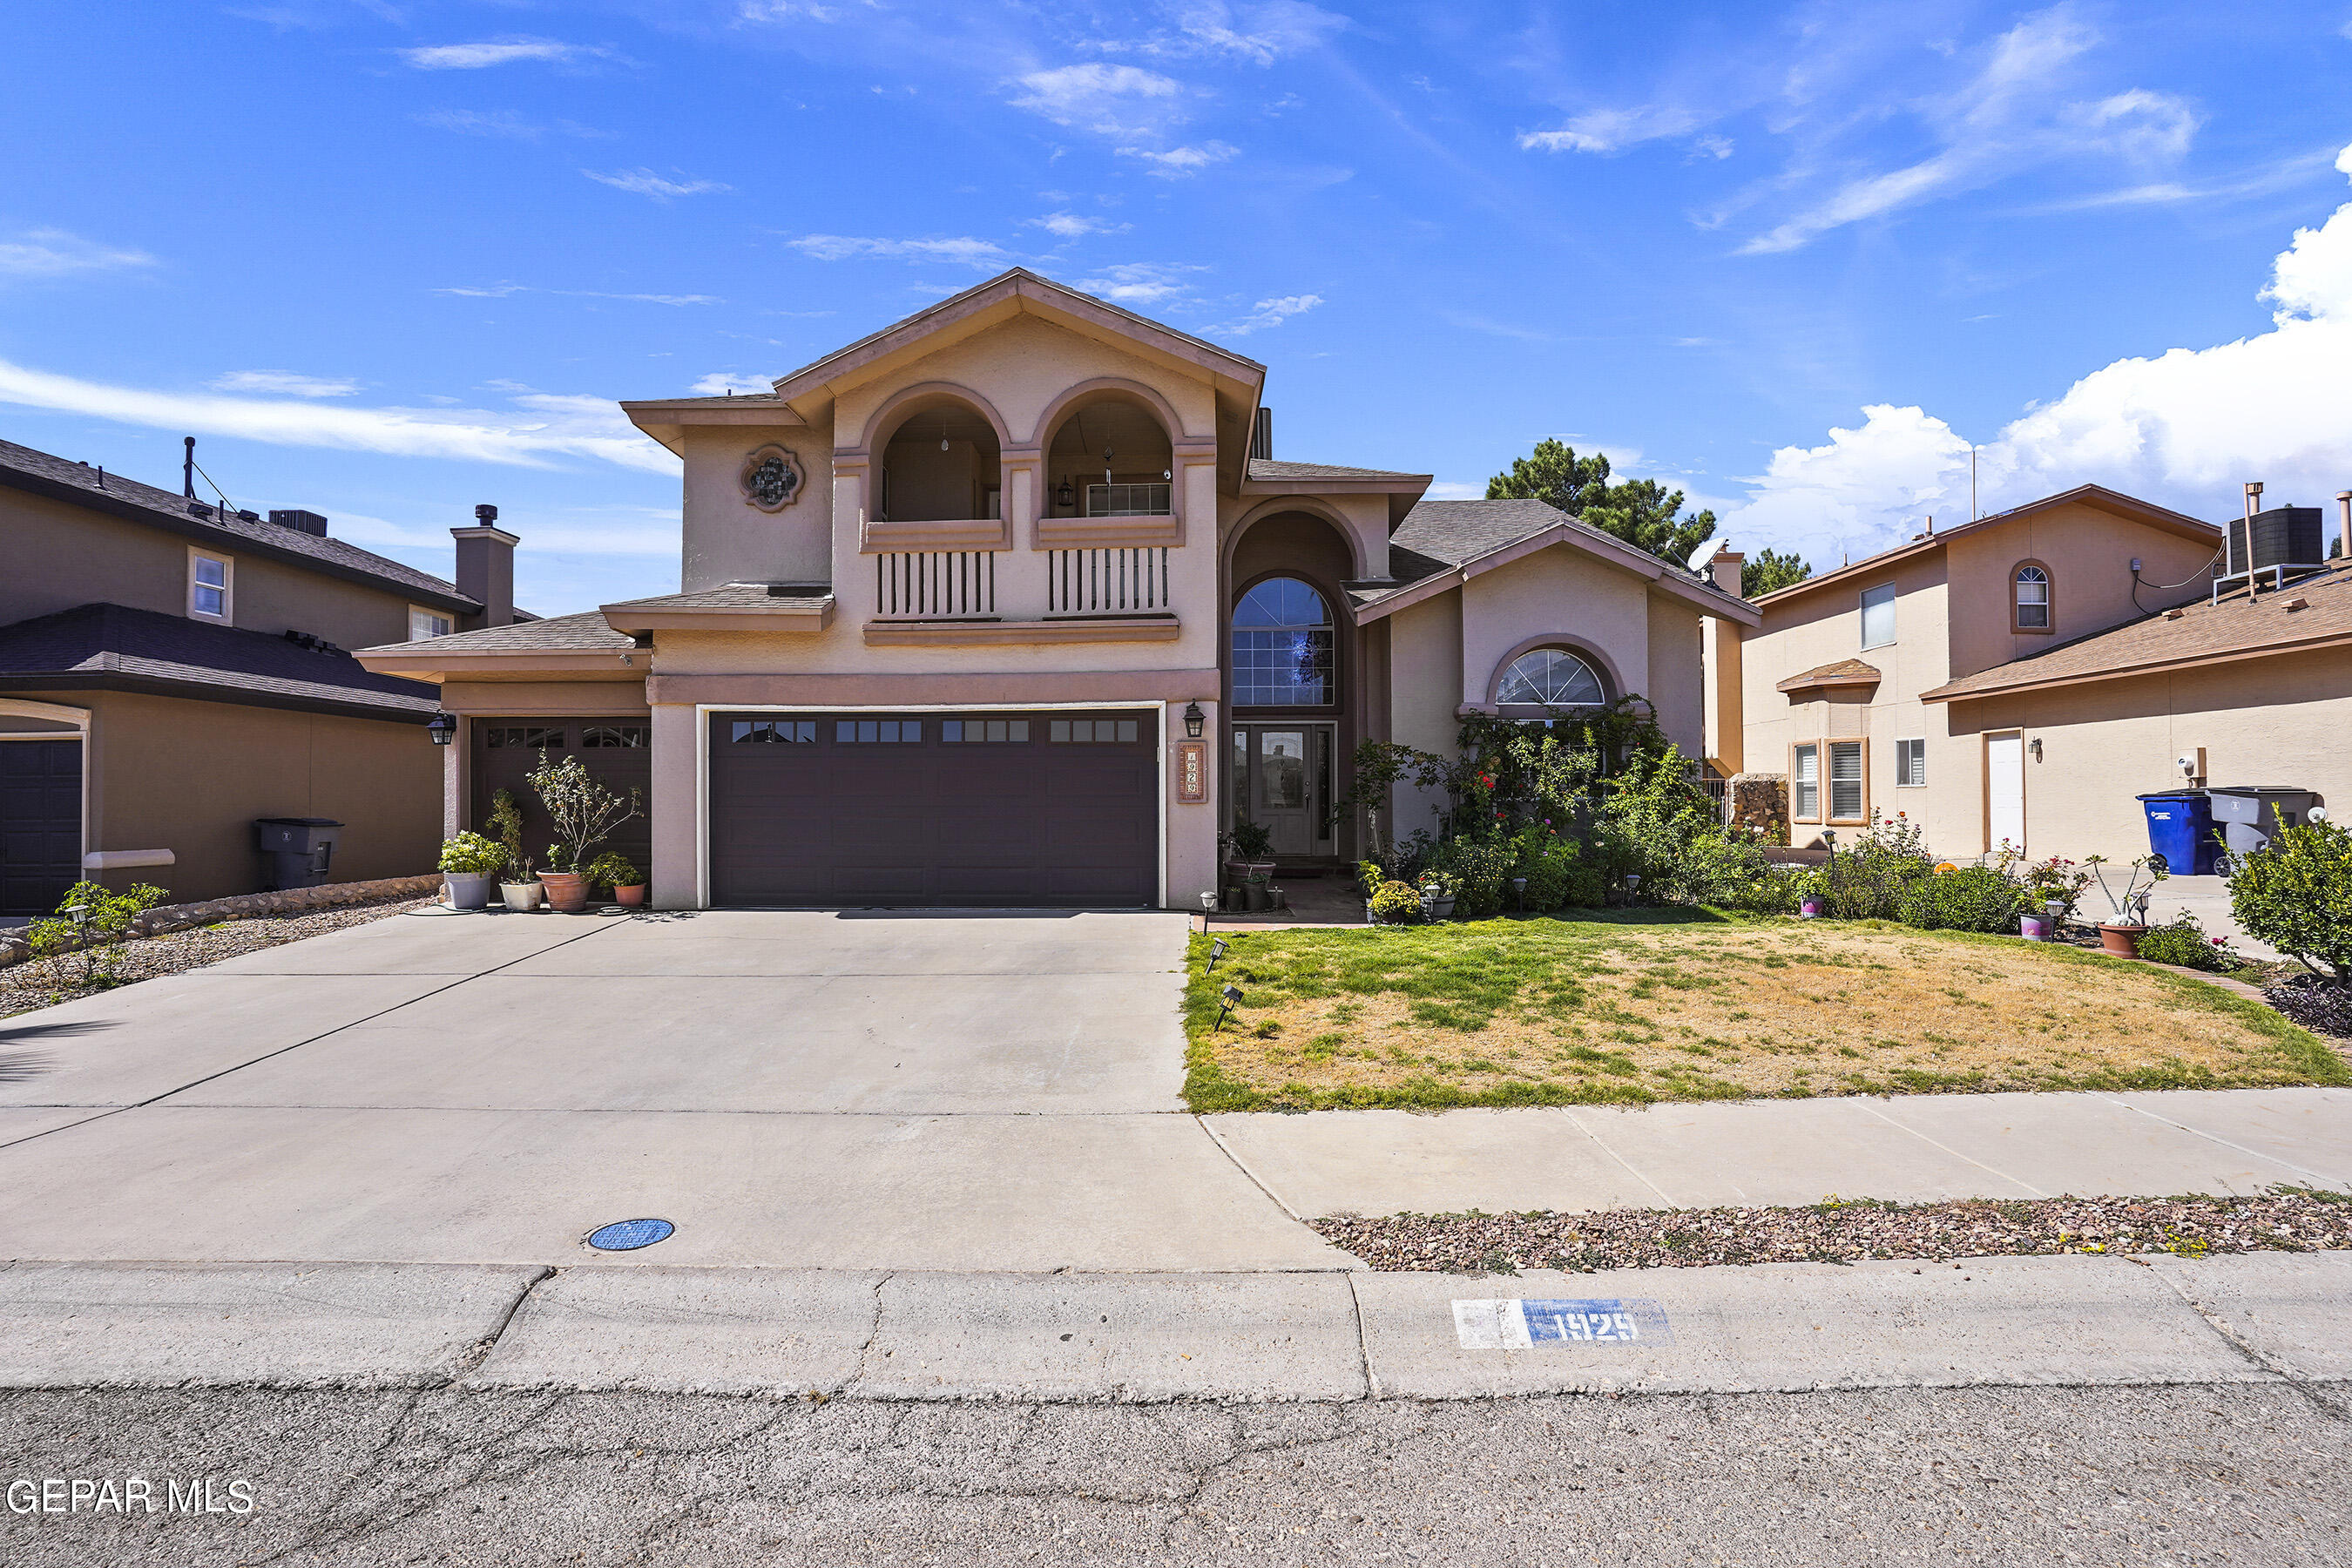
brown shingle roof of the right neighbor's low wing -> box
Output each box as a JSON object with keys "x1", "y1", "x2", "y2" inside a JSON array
[{"x1": 1919, "y1": 566, "x2": 2352, "y2": 703}]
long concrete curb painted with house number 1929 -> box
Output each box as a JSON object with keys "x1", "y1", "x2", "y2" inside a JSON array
[{"x1": 0, "y1": 1253, "x2": 2352, "y2": 1403}]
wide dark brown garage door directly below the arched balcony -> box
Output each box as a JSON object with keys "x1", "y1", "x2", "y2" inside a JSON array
[{"x1": 710, "y1": 710, "x2": 1159, "y2": 908}]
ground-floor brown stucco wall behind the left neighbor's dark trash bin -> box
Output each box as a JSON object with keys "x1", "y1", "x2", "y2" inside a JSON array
[{"x1": 66, "y1": 691, "x2": 443, "y2": 902}]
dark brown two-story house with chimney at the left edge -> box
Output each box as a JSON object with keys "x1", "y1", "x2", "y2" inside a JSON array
[{"x1": 0, "y1": 442, "x2": 513, "y2": 915}]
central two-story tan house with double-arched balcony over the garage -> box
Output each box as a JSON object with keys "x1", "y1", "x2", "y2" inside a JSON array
[{"x1": 343, "y1": 270, "x2": 1757, "y2": 908}]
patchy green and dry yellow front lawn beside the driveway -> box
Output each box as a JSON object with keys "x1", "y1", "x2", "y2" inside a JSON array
[{"x1": 1186, "y1": 909, "x2": 2352, "y2": 1112}]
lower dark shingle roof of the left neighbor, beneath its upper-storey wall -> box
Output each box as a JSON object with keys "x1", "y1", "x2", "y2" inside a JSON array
[{"x1": 0, "y1": 605, "x2": 440, "y2": 724}]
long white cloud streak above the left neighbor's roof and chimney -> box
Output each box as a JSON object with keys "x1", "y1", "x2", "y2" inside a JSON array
[{"x1": 0, "y1": 360, "x2": 678, "y2": 472}]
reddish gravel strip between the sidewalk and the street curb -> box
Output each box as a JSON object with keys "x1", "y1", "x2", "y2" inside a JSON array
[{"x1": 1308, "y1": 1187, "x2": 2352, "y2": 1274}]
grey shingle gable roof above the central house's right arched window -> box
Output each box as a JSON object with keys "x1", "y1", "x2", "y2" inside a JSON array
[{"x1": 1348, "y1": 501, "x2": 1761, "y2": 625}]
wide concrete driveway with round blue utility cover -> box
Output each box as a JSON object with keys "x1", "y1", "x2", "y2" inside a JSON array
[{"x1": 0, "y1": 912, "x2": 1350, "y2": 1269}]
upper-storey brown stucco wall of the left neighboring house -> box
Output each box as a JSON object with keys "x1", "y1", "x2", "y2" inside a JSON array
[{"x1": 0, "y1": 487, "x2": 425, "y2": 649}]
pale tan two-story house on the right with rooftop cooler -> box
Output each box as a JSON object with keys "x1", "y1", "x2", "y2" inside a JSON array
[{"x1": 1707, "y1": 484, "x2": 2267, "y2": 858}]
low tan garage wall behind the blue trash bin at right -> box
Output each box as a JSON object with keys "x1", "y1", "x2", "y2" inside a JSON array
[{"x1": 1931, "y1": 649, "x2": 2352, "y2": 869}]
